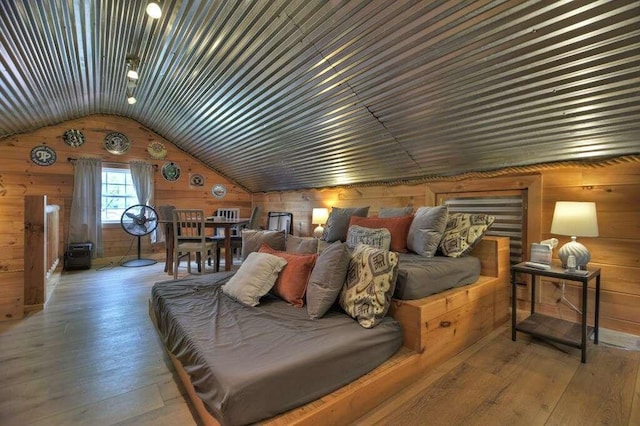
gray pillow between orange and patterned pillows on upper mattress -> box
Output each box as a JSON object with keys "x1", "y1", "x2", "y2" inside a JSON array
[{"x1": 407, "y1": 205, "x2": 448, "y2": 257}]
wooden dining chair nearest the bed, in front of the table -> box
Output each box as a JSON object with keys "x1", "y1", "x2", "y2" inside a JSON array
[{"x1": 173, "y1": 209, "x2": 219, "y2": 279}]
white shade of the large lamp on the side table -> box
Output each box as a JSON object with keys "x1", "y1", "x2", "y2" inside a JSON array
[{"x1": 551, "y1": 201, "x2": 598, "y2": 237}]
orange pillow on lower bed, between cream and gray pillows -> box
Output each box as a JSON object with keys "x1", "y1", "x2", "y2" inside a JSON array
[{"x1": 259, "y1": 244, "x2": 318, "y2": 308}]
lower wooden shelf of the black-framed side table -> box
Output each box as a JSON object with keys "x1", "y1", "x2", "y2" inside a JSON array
[{"x1": 516, "y1": 313, "x2": 594, "y2": 348}]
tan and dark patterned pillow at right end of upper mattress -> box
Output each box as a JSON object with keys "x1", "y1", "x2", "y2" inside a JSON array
[{"x1": 440, "y1": 213, "x2": 495, "y2": 257}]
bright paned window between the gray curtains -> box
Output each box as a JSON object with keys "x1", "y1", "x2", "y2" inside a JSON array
[{"x1": 101, "y1": 167, "x2": 138, "y2": 223}]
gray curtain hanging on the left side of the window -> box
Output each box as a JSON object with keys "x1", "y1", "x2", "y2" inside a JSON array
[{"x1": 69, "y1": 158, "x2": 104, "y2": 258}]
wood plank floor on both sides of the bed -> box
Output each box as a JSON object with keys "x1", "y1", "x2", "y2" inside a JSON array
[{"x1": 0, "y1": 264, "x2": 640, "y2": 426}]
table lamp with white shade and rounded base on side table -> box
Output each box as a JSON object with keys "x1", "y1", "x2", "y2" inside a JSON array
[{"x1": 551, "y1": 201, "x2": 598, "y2": 269}]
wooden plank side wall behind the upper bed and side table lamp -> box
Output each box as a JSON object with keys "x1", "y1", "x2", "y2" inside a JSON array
[{"x1": 253, "y1": 157, "x2": 640, "y2": 335}]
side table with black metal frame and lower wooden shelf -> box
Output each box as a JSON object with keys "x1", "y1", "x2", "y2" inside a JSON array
[{"x1": 511, "y1": 263, "x2": 600, "y2": 363}]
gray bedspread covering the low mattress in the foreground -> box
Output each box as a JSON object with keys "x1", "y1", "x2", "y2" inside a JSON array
[{"x1": 151, "y1": 273, "x2": 402, "y2": 425}]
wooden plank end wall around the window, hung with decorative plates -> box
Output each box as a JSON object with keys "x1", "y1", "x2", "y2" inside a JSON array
[{"x1": 0, "y1": 115, "x2": 252, "y2": 320}]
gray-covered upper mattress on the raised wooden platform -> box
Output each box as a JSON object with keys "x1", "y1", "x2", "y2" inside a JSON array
[{"x1": 393, "y1": 253, "x2": 480, "y2": 300}]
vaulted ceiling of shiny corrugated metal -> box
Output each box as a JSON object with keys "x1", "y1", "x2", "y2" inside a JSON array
[{"x1": 0, "y1": 0, "x2": 640, "y2": 191}]
